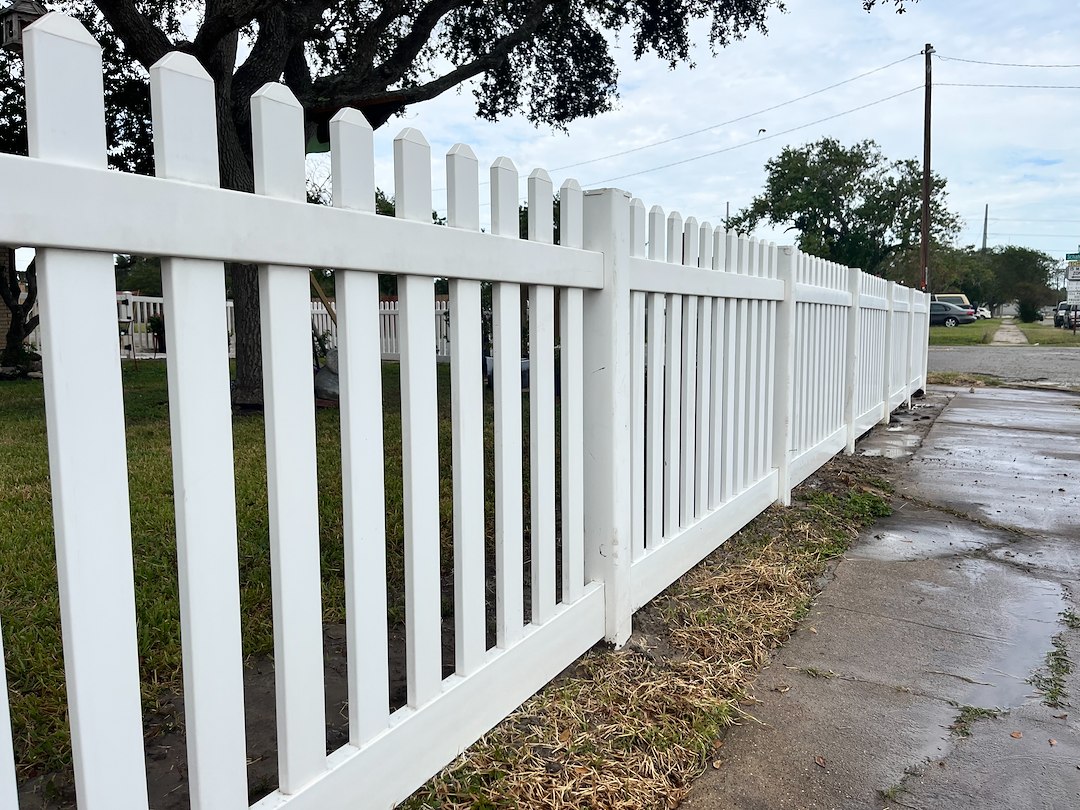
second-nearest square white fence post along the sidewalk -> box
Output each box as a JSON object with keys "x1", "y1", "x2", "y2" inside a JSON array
[{"x1": 772, "y1": 246, "x2": 798, "y2": 507}]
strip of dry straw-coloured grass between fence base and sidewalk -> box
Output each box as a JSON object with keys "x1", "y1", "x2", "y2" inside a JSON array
[{"x1": 404, "y1": 458, "x2": 889, "y2": 810}]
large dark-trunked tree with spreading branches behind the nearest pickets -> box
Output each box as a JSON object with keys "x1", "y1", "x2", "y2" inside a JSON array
[{"x1": 0, "y1": 0, "x2": 917, "y2": 404}]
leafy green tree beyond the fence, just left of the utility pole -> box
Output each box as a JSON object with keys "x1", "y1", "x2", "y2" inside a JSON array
[{"x1": 726, "y1": 137, "x2": 960, "y2": 278}]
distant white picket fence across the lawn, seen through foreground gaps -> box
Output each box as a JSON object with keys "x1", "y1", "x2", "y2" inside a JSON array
[{"x1": 27, "y1": 293, "x2": 450, "y2": 362}]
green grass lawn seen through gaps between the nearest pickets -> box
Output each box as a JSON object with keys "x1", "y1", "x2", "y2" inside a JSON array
[{"x1": 0, "y1": 362, "x2": 511, "y2": 777}]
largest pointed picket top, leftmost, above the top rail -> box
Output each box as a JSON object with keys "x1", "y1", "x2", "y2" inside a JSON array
[{"x1": 24, "y1": 12, "x2": 108, "y2": 168}]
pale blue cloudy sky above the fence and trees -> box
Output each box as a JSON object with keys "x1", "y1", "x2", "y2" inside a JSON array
[{"x1": 14, "y1": 0, "x2": 1080, "y2": 276}]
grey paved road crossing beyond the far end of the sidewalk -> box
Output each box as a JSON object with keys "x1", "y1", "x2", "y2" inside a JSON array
[{"x1": 929, "y1": 346, "x2": 1080, "y2": 389}]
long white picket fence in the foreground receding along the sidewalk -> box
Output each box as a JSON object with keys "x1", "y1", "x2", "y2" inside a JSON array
[{"x1": 0, "y1": 13, "x2": 928, "y2": 810}]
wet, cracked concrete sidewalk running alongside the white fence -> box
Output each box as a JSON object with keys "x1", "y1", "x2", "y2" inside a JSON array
[{"x1": 683, "y1": 389, "x2": 1080, "y2": 810}]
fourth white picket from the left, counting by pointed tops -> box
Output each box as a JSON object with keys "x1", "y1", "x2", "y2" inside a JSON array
[{"x1": 330, "y1": 110, "x2": 390, "y2": 746}]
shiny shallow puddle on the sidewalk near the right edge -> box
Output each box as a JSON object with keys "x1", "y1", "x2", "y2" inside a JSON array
[{"x1": 961, "y1": 559, "x2": 1066, "y2": 708}]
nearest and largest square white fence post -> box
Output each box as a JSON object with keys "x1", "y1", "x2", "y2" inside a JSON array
[{"x1": 584, "y1": 189, "x2": 633, "y2": 645}]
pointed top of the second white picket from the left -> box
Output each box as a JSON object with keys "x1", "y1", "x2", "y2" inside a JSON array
[{"x1": 150, "y1": 51, "x2": 219, "y2": 186}]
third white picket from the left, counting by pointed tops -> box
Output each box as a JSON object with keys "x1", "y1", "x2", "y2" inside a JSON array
[{"x1": 252, "y1": 84, "x2": 326, "y2": 794}]
